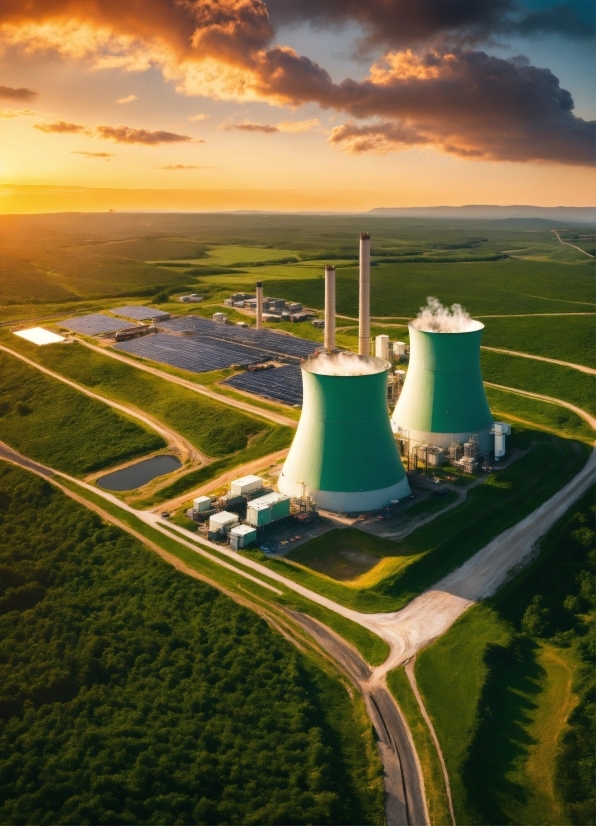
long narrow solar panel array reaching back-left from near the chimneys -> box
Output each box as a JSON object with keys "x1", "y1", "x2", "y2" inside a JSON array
[{"x1": 159, "y1": 316, "x2": 320, "y2": 359}]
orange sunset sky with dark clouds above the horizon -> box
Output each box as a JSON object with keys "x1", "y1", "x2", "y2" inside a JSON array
[{"x1": 0, "y1": 0, "x2": 596, "y2": 212}]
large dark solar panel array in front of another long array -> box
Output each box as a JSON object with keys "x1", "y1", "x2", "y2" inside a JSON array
[{"x1": 116, "y1": 333, "x2": 269, "y2": 373}]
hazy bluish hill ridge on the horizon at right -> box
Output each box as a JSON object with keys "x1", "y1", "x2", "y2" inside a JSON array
[{"x1": 366, "y1": 204, "x2": 596, "y2": 224}]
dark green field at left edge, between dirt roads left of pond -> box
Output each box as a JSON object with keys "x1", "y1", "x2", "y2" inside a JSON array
[{"x1": 0, "y1": 353, "x2": 166, "y2": 475}]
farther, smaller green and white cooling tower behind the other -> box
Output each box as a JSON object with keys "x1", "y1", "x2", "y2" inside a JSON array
[{"x1": 391, "y1": 319, "x2": 493, "y2": 452}]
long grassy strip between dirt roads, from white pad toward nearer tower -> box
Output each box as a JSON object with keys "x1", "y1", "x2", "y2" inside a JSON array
[{"x1": 5, "y1": 336, "x2": 271, "y2": 456}]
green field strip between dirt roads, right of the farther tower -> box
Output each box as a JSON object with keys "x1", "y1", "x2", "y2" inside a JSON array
[{"x1": 480, "y1": 350, "x2": 596, "y2": 414}]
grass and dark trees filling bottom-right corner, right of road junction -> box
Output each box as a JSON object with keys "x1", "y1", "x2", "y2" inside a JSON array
[{"x1": 416, "y1": 491, "x2": 596, "y2": 826}]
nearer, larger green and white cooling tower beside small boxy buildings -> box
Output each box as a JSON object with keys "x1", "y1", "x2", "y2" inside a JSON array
[{"x1": 278, "y1": 354, "x2": 410, "y2": 513}]
